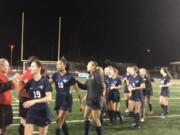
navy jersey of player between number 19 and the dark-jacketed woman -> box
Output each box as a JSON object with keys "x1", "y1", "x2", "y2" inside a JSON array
[{"x1": 52, "y1": 72, "x2": 76, "y2": 94}]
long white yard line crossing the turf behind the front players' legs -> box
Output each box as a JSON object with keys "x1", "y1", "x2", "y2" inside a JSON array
[{"x1": 10, "y1": 114, "x2": 180, "y2": 127}]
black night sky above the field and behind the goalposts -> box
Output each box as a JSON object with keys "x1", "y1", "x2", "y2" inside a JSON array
[{"x1": 0, "y1": 0, "x2": 180, "y2": 67}]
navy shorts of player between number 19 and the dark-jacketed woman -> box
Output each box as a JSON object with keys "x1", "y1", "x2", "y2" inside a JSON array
[{"x1": 55, "y1": 94, "x2": 73, "y2": 112}]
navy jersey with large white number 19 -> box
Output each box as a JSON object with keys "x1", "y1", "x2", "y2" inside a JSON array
[{"x1": 25, "y1": 77, "x2": 52, "y2": 99}]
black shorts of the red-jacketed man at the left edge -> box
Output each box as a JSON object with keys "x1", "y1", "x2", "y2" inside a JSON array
[{"x1": 0, "y1": 105, "x2": 13, "y2": 128}]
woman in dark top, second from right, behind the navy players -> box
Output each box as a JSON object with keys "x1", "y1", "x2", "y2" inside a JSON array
[{"x1": 139, "y1": 68, "x2": 153, "y2": 122}]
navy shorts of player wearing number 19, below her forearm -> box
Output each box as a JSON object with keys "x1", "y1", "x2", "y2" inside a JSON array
[{"x1": 26, "y1": 103, "x2": 52, "y2": 127}]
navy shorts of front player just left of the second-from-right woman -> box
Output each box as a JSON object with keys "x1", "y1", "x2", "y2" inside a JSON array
[{"x1": 130, "y1": 90, "x2": 143, "y2": 102}]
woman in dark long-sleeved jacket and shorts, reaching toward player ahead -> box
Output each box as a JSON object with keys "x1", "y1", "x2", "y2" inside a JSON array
[{"x1": 78, "y1": 61, "x2": 105, "y2": 135}]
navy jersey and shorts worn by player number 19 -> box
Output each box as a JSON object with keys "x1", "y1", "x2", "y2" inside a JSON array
[{"x1": 25, "y1": 77, "x2": 52, "y2": 127}]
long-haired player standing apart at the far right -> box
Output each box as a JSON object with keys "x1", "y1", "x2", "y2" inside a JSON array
[{"x1": 159, "y1": 67, "x2": 171, "y2": 119}]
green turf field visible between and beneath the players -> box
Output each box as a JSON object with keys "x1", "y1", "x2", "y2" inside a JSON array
[{"x1": 8, "y1": 80, "x2": 180, "y2": 135}]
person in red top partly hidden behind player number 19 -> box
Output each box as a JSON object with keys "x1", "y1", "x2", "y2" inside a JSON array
[{"x1": 15, "y1": 56, "x2": 38, "y2": 135}]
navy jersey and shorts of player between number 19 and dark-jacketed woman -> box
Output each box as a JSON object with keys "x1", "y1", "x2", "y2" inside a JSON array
[{"x1": 52, "y1": 72, "x2": 76, "y2": 111}]
